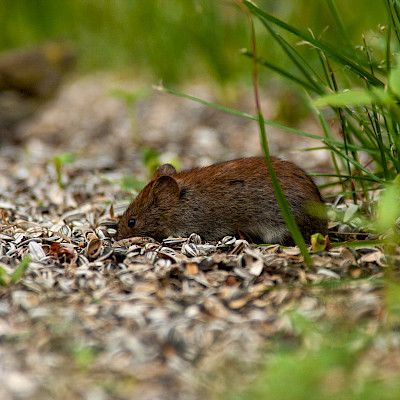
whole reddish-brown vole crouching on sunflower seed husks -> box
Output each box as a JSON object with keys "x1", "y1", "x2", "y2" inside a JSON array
[{"x1": 117, "y1": 157, "x2": 327, "y2": 244}]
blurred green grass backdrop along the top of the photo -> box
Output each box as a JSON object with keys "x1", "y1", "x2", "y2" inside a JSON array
[{"x1": 0, "y1": 0, "x2": 386, "y2": 84}]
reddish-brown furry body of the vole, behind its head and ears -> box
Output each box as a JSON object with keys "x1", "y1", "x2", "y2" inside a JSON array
[{"x1": 173, "y1": 157, "x2": 326, "y2": 244}]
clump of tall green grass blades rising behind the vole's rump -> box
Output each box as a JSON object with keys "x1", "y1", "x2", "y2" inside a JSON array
[{"x1": 243, "y1": 0, "x2": 400, "y2": 202}]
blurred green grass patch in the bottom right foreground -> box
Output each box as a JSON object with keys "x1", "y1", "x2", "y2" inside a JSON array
[{"x1": 225, "y1": 283, "x2": 400, "y2": 400}]
